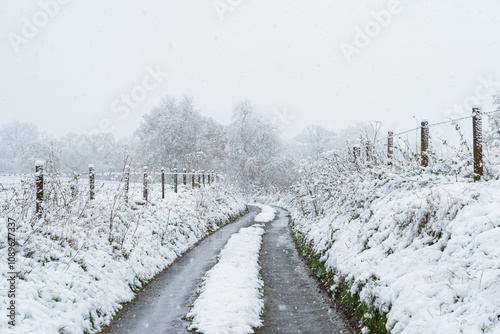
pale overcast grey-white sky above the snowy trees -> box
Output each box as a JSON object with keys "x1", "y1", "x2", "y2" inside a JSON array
[{"x1": 0, "y1": 0, "x2": 500, "y2": 136}]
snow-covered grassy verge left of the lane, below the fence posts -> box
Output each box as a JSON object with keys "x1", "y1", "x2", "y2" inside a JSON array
[{"x1": 0, "y1": 175, "x2": 246, "y2": 334}]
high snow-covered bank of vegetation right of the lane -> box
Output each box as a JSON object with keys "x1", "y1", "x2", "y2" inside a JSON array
[{"x1": 258, "y1": 154, "x2": 500, "y2": 333}]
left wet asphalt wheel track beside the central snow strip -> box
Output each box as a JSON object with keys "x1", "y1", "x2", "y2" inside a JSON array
[{"x1": 102, "y1": 207, "x2": 260, "y2": 334}]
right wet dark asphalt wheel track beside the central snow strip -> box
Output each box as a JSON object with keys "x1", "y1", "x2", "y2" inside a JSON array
[{"x1": 255, "y1": 209, "x2": 355, "y2": 334}]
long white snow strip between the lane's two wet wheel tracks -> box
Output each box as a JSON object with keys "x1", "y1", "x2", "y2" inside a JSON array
[{"x1": 187, "y1": 224, "x2": 264, "y2": 334}]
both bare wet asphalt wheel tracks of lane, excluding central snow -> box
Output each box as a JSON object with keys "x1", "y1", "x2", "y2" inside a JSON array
[{"x1": 101, "y1": 207, "x2": 354, "y2": 334}]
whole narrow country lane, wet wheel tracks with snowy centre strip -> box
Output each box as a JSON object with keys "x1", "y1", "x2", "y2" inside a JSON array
[{"x1": 102, "y1": 204, "x2": 354, "y2": 334}]
